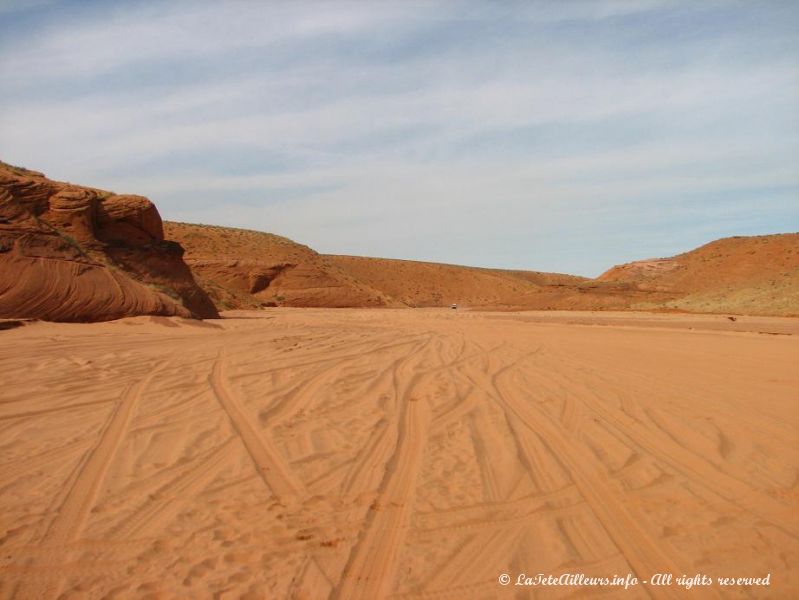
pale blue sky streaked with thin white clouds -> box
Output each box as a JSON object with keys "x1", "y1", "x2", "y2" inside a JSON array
[{"x1": 0, "y1": 0, "x2": 799, "y2": 276}]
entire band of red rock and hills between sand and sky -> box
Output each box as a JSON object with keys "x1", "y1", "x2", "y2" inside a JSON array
[{"x1": 0, "y1": 163, "x2": 799, "y2": 321}]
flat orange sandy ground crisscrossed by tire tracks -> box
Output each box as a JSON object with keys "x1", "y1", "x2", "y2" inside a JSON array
[{"x1": 0, "y1": 309, "x2": 799, "y2": 599}]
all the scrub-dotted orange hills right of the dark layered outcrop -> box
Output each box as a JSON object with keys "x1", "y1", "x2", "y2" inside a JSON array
[{"x1": 164, "y1": 222, "x2": 799, "y2": 315}]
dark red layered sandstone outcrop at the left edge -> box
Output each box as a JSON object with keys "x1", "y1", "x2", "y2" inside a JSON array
[{"x1": 0, "y1": 163, "x2": 218, "y2": 321}]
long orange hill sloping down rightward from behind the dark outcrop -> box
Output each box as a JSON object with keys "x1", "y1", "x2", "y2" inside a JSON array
[{"x1": 164, "y1": 221, "x2": 608, "y2": 309}]
